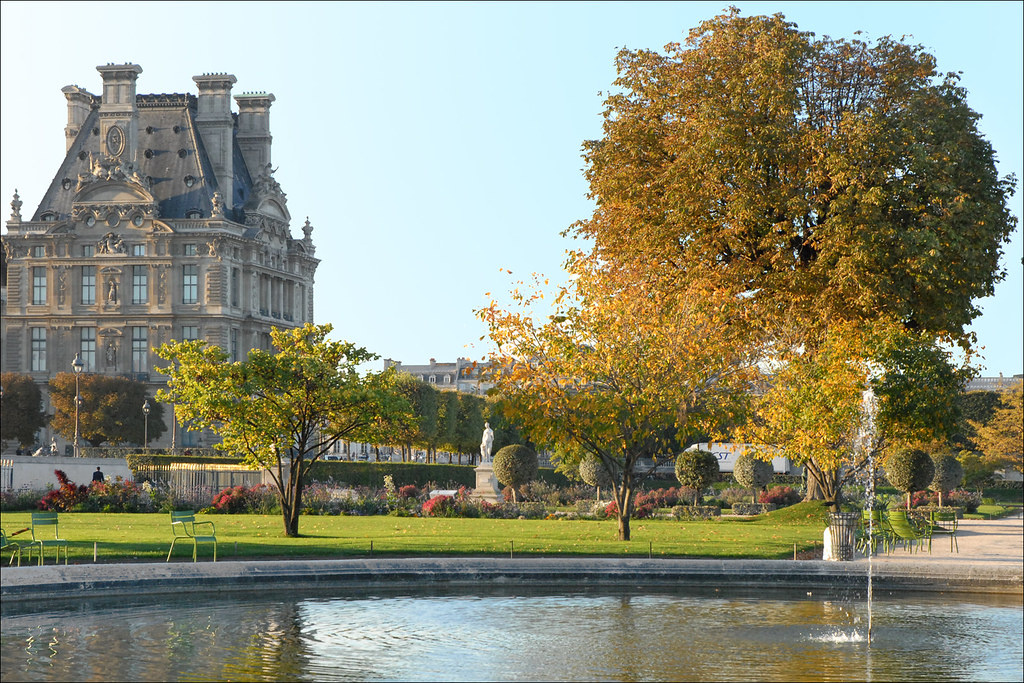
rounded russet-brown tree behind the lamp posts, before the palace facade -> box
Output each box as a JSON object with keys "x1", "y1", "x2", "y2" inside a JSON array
[{"x1": 49, "y1": 373, "x2": 167, "y2": 446}]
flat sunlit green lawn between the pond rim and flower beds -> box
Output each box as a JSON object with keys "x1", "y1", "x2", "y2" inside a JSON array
[{"x1": 0, "y1": 503, "x2": 825, "y2": 563}]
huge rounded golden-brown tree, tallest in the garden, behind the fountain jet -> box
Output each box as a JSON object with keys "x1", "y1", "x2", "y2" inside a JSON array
[{"x1": 570, "y1": 8, "x2": 1017, "y2": 496}]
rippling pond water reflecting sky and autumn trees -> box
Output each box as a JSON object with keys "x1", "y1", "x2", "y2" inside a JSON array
[{"x1": 0, "y1": 590, "x2": 1024, "y2": 681}]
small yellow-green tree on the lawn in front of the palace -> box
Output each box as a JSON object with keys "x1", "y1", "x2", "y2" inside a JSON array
[{"x1": 157, "y1": 323, "x2": 412, "y2": 537}]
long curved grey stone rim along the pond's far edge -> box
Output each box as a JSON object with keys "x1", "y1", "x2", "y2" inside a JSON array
[{"x1": 0, "y1": 557, "x2": 1024, "y2": 603}]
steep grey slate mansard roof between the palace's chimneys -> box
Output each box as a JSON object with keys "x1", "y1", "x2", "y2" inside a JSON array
[{"x1": 32, "y1": 93, "x2": 253, "y2": 222}]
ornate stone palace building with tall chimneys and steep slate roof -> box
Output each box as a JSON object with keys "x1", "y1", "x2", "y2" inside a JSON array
[{"x1": 0, "y1": 63, "x2": 318, "y2": 445}]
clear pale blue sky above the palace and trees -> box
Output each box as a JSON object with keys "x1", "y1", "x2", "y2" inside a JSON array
[{"x1": 0, "y1": 2, "x2": 1024, "y2": 375}]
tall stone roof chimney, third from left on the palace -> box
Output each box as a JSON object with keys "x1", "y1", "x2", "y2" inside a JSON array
[{"x1": 193, "y1": 74, "x2": 238, "y2": 209}]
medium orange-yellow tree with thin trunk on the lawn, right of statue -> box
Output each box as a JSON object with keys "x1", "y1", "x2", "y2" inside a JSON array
[{"x1": 479, "y1": 256, "x2": 751, "y2": 541}]
